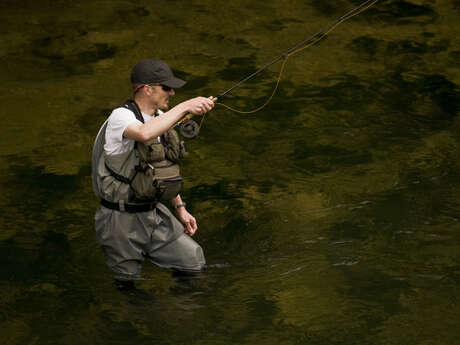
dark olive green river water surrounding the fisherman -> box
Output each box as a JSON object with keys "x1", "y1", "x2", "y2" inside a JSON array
[{"x1": 0, "y1": 0, "x2": 460, "y2": 345}]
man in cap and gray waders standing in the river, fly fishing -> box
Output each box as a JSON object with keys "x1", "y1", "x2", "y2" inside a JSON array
[{"x1": 92, "y1": 59, "x2": 214, "y2": 288}]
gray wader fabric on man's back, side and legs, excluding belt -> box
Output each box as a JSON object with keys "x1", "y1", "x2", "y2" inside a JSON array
[{"x1": 92, "y1": 109, "x2": 205, "y2": 279}]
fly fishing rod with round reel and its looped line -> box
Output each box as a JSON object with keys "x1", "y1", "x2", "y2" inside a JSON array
[{"x1": 176, "y1": 0, "x2": 378, "y2": 139}]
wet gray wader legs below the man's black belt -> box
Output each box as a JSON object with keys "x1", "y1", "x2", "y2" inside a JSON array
[{"x1": 95, "y1": 204, "x2": 205, "y2": 278}]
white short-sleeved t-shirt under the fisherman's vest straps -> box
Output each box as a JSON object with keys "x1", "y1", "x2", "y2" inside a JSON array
[{"x1": 104, "y1": 107, "x2": 162, "y2": 155}]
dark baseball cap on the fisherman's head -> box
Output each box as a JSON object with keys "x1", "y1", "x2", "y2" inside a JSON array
[{"x1": 131, "y1": 59, "x2": 185, "y2": 89}]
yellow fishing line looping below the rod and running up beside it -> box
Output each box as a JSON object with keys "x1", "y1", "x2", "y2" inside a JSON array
[{"x1": 200, "y1": 0, "x2": 378, "y2": 128}]
